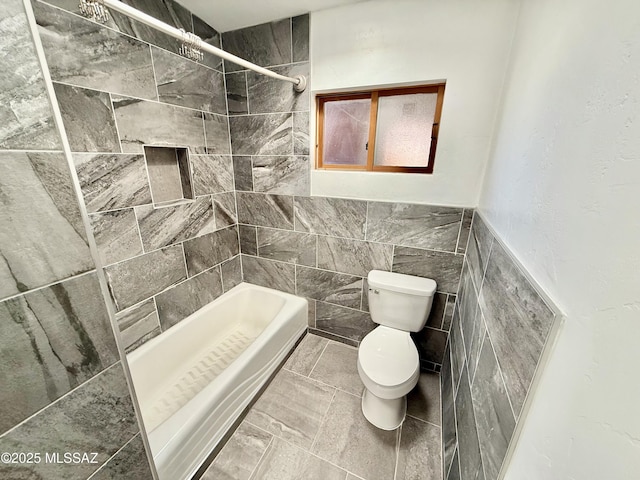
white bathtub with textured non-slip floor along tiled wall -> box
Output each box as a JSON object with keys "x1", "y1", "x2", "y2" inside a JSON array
[{"x1": 127, "y1": 283, "x2": 307, "y2": 480}]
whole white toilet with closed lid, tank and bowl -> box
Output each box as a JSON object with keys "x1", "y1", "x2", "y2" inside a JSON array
[{"x1": 358, "y1": 270, "x2": 436, "y2": 430}]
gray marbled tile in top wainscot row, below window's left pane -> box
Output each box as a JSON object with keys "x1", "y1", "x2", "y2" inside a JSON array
[{"x1": 295, "y1": 197, "x2": 367, "y2": 240}]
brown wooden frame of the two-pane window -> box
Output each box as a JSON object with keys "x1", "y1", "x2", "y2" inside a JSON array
[{"x1": 316, "y1": 83, "x2": 445, "y2": 173}]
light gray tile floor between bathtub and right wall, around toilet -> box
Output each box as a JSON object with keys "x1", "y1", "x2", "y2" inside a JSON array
[{"x1": 201, "y1": 334, "x2": 442, "y2": 480}]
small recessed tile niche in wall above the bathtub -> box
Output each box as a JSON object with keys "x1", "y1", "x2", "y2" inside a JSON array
[{"x1": 144, "y1": 146, "x2": 195, "y2": 207}]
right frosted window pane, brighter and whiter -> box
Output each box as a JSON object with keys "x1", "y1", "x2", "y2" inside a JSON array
[{"x1": 373, "y1": 93, "x2": 438, "y2": 167}]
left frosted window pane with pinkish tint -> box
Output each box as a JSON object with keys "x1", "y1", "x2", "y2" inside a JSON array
[{"x1": 322, "y1": 98, "x2": 371, "y2": 165}]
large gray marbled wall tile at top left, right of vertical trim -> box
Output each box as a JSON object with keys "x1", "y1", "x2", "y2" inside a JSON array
[{"x1": 33, "y1": 2, "x2": 157, "y2": 100}]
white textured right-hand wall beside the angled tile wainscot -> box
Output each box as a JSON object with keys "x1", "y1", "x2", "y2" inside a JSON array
[{"x1": 480, "y1": 0, "x2": 640, "y2": 480}]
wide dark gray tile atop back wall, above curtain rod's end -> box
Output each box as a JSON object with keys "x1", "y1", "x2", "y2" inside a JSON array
[{"x1": 222, "y1": 18, "x2": 291, "y2": 72}]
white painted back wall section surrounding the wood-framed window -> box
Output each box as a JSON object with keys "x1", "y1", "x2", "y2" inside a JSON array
[{"x1": 311, "y1": 0, "x2": 519, "y2": 206}]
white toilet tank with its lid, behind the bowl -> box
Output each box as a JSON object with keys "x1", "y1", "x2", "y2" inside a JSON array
[{"x1": 367, "y1": 270, "x2": 437, "y2": 332}]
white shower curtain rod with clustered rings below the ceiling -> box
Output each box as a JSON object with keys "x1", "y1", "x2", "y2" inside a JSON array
[{"x1": 89, "y1": 0, "x2": 307, "y2": 92}]
